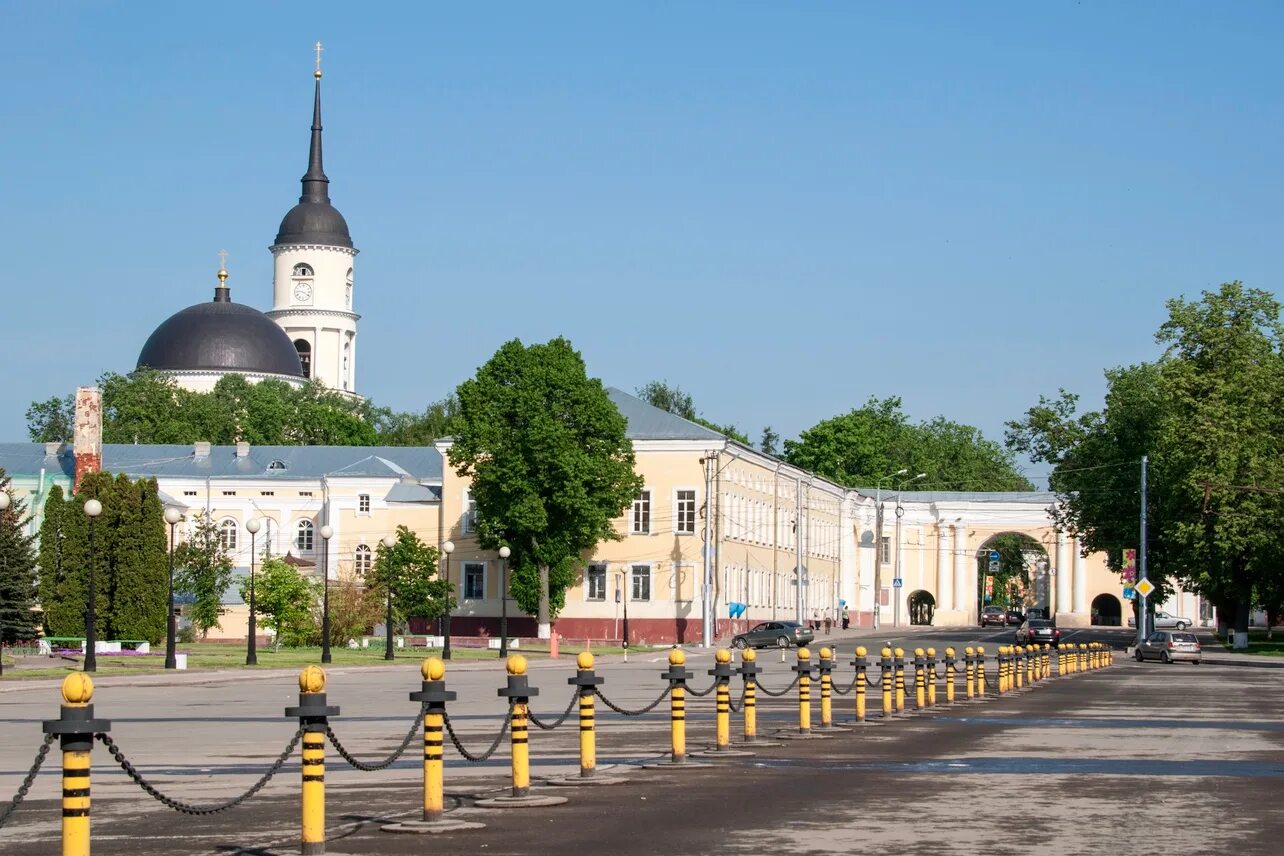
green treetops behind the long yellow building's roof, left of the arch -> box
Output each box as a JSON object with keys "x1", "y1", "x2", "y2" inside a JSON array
[{"x1": 785, "y1": 397, "x2": 1034, "y2": 490}]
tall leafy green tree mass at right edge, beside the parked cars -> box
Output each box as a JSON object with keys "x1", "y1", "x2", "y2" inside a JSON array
[{"x1": 1008, "y1": 282, "x2": 1284, "y2": 646}]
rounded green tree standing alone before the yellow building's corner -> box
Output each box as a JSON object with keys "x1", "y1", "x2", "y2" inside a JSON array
[{"x1": 449, "y1": 338, "x2": 642, "y2": 637}]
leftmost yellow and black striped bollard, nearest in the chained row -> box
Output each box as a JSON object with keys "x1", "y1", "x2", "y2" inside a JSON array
[{"x1": 42, "y1": 671, "x2": 112, "y2": 856}]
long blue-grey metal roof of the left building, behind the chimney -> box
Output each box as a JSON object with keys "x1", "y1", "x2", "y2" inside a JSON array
[{"x1": 0, "y1": 443, "x2": 442, "y2": 483}]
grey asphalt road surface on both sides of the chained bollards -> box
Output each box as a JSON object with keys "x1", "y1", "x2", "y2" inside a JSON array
[{"x1": 0, "y1": 629, "x2": 1284, "y2": 856}]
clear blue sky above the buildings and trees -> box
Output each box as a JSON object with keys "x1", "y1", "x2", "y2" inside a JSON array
[{"x1": 0, "y1": 0, "x2": 1284, "y2": 481}]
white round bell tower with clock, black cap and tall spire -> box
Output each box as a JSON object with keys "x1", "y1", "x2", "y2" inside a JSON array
[{"x1": 266, "y1": 42, "x2": 361, "y2": 395}]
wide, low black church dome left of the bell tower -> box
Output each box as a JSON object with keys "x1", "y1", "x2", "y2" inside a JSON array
[{"x1": 139, "y1": 287, "x2": 303, "y2": 377}]
